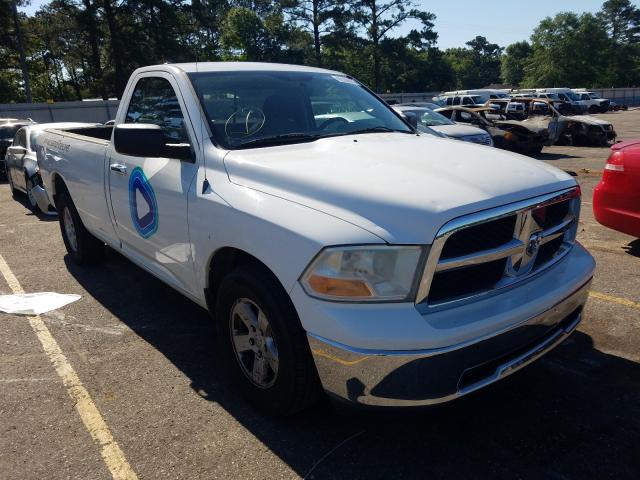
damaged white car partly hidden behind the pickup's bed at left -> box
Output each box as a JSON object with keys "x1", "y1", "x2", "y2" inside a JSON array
[{"x1": 5, "y1": 122, "x2": 95, "y2": 215}]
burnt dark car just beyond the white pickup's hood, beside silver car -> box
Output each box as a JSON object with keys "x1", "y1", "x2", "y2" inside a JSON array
[{"x1": 437, "y1": 107, "x2": 553, "y2": 154}]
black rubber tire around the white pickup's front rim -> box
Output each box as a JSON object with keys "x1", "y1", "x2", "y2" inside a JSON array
[{"x1": 215, "y1": 265, "x2": 321, "y2": 416}]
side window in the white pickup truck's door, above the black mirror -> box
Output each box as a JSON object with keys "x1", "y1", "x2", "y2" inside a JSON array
[{"x1": 125, "y1": 77, "x2": 189, "y2": 143}]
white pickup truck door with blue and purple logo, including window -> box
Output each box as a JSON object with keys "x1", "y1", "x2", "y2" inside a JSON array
[{"x1": 108, "y1": 72, "x2": 198, "y2": 292}]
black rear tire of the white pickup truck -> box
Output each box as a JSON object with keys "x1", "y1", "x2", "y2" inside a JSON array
[{"x1": 56, "y1": 192, "x2": 104, "y2": 265}]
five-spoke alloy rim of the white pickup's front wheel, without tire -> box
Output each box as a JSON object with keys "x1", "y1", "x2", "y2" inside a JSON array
[{"x1": 229, "y1": 298, "x2": 280, "y2": 388}]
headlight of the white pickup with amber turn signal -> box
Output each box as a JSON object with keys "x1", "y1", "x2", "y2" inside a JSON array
[{"x1": 300, "y1": 245, "x2": 423, "y2": 302}]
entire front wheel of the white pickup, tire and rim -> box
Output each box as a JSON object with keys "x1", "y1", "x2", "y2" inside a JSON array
[{"x1": 215, "y1": 265, "x2": 321, "y2": 415}]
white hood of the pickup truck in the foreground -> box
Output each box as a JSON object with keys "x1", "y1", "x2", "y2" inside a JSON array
[{"x1": 224, "y1": 133, "x2": 575, "y2": 244}]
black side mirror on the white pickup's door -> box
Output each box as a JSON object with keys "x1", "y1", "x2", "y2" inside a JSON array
[{"x1": 113, "y1": 123, "x2": 193, "y2": 161}]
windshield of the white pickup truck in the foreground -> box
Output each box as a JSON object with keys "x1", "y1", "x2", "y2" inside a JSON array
[{"x1": 189, "y1": 71, "x2": 413, "y2": 149}]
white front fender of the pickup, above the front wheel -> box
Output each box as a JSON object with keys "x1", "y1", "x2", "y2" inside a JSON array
[{"x1": 189, "y1": 172, "x2": 384, "y2": 300}]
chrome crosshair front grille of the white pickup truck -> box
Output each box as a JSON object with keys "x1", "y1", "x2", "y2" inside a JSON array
[{"x1": 417, "y1": 187, "x2": 580, "y2": 307}]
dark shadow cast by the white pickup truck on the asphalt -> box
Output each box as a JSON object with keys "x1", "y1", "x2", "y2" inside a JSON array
[{"x1": 65, "y1": 252, "x2": 640, "y2": 479}]
